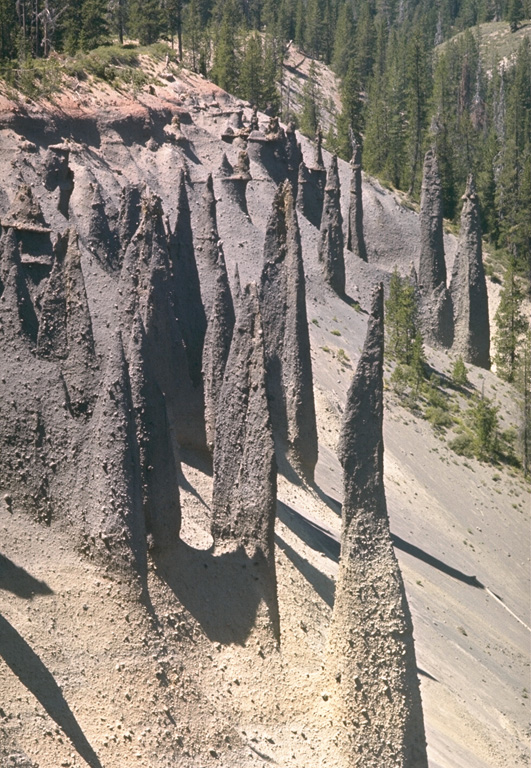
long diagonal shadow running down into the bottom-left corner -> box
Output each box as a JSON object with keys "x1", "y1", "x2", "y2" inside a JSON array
[{"x1": 0, "y1": 616, "x2": 102, "y2": 768}]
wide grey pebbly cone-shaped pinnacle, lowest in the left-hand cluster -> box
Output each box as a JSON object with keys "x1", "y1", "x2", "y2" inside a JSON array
[{"x1": 79, "y1": 332, "x2": 146, "y2": 573}]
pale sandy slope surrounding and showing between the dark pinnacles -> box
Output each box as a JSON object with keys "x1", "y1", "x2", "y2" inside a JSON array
[{"x1": 0, "y1": 58, "x2": 531, "y2": 768}]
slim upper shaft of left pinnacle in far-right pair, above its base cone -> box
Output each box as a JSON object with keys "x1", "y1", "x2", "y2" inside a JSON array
[{"x1": 418, "y1": 149, "x2": 446, "y2": 294}]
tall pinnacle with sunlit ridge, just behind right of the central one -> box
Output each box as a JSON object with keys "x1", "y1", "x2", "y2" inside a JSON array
[{"x1": 260, "y1": 181, "x2": 317, "y2": 480}]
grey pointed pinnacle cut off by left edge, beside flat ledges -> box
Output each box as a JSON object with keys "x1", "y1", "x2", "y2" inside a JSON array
[{"x1": 0, "y1": 228, "x2": 39, "y2": 345}]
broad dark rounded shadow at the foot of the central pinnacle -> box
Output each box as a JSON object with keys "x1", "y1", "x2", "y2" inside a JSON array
[{"x1": 156, "y1": 541, "x2": 271, "y2": 645}]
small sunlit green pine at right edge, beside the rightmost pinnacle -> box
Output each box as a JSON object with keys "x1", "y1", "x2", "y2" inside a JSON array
[{"x1": 494, "y1": 259, "x2": 527, "y2": 382}]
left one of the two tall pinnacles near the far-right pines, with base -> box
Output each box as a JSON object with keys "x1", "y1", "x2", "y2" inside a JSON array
[{"x1": 418, "y1": 149, "x2": 453, "y2": 348}]
